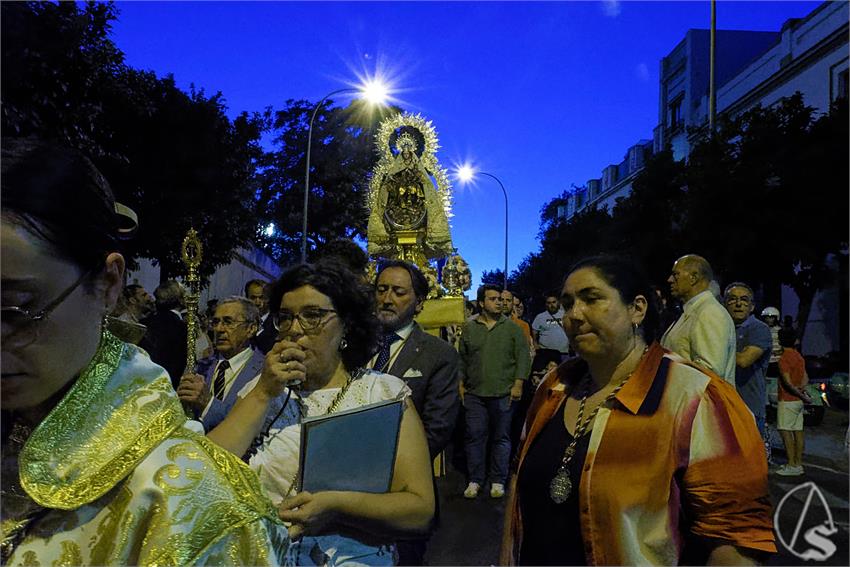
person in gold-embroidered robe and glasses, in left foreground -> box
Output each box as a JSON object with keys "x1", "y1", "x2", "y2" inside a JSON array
[{"x1": 0, "y1": 139, "x2": 286, "y2": 565}]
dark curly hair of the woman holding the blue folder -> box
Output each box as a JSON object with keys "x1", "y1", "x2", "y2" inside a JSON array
[{"x1": 269, "y1": 258, "x2": 380, "y2": 372}]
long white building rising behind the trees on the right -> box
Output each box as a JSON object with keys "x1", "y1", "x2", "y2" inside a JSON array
[{"x1": 559, "y1": 0, "x2": 850, "y2": 354}]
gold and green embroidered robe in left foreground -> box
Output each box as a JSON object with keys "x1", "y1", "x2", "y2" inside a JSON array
[{"x1": 2, "y1": 332, "x2": 288, "y2": 565}]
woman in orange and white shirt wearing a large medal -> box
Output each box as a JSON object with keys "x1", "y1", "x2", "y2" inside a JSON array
[{"x1": 501, "y1": 257, "x2": 776, "y2": 565}]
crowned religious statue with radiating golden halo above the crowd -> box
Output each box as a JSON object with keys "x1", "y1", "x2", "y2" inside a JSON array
[{"x1": 367, "y1": 114, "x2": 453, "y2": 269}]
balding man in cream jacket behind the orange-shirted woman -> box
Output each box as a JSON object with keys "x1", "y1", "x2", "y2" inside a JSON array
[{"x1": 661, "y1": 254, "x2": 735, "y2": 386}]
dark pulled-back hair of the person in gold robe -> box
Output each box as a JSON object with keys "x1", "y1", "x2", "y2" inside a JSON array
[{"x1": 2, "y1": 138, "x2": 119, "y2": 271}]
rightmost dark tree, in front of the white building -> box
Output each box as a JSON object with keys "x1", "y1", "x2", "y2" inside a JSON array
[{"x1": 685, "y1": 93, "x2": 848, "y2": 342}]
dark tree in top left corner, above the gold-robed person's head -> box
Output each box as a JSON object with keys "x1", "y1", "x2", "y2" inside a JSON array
[{"x1": 0, "y1": 2, "x2": 124, "y2": 156}]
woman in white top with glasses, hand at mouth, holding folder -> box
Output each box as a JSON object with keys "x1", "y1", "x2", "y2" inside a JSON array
[{"x1": 208, "y1": 260, "x2": 434, "y2": 565}]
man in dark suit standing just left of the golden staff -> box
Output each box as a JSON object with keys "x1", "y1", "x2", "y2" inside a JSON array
[{"x1": 139, "y1": 280, "x2": 187, "y2": 389}]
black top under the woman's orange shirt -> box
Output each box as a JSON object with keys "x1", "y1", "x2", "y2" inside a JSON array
[{"x1": 517, "y1": 402, "x2": 590, "y2": 565}]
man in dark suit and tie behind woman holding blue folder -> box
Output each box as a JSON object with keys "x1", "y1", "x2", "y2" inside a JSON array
[{"x1": 371, "y1": 260, "x2": 460, "y2": 565}]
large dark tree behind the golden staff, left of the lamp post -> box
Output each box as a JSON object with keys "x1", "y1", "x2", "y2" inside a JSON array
[{"x1": 96, "y1": 75, "x2": 262, "y2": 279}]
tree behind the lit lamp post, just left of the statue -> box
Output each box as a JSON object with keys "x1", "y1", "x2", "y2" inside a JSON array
[{"x1": 257, "y1": 100, "x2": 398, "y2": 262}]
